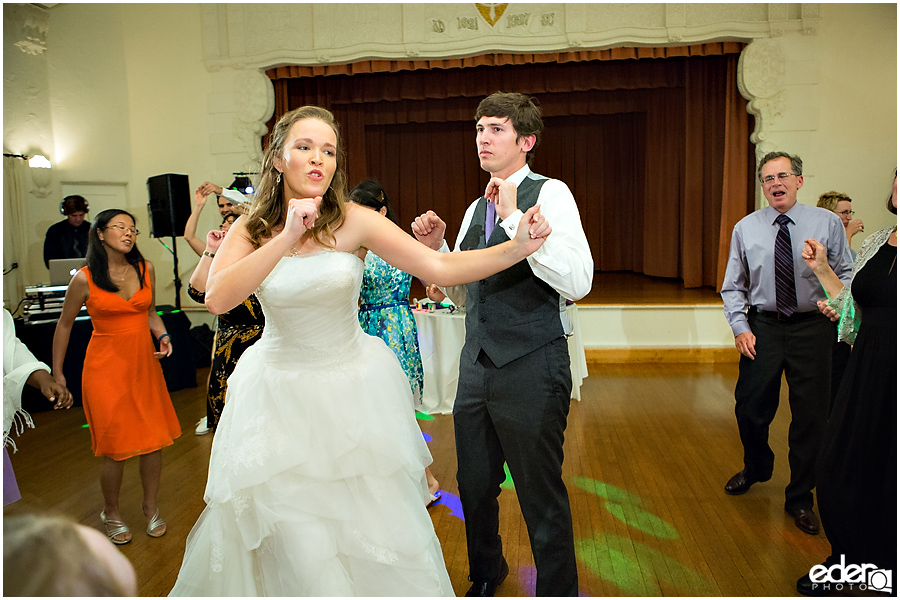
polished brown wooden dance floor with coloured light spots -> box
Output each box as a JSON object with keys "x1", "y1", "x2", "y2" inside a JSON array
[{"x1": 4, "y1": 363, "x2": 829, "y2": 596}]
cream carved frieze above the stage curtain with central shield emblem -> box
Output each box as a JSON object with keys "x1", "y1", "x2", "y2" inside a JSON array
[{"x1": 200, "y1": 2, "x2": 819, "y2": 71}]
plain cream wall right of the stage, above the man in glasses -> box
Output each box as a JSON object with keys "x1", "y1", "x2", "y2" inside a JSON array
[{"x1": 762, "y1": 4, "x2": 897, "y2": 249}]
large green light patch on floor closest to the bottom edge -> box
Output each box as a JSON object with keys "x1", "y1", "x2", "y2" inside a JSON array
[{"x1": 575, "y1": 533, "x2": 713, "y2": 596}]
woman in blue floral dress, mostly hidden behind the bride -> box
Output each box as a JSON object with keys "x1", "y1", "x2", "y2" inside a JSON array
[{"x1": 350, "y1": 179, "x2": 440, "y2": 505}]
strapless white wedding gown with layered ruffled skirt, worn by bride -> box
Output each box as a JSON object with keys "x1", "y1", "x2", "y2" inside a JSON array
[{"x1": 170, "y1": 251, "x2": 453, "y2": 596}]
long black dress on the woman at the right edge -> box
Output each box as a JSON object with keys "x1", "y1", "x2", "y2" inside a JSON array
[{"x1": 817, "y1": 243, "x2": 897, "y2": 572}]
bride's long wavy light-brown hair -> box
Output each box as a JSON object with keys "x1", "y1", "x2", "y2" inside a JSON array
[{"x1": 245, "y1": 106, "x2": 347, "y2": 248}]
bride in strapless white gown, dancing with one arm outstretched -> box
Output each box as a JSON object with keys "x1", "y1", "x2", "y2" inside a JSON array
[{"x1": 170, "y1": 107, "x2": 550, "y2": 596}]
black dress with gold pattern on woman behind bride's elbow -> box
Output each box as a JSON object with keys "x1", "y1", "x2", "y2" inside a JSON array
[{"x1": 188, "y1": 285, "x2": 266, "y2": 428}]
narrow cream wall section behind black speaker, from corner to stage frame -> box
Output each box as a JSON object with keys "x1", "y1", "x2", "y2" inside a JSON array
[{"x1": 123, "y1": 4, "x2": 216, "y2": 306}]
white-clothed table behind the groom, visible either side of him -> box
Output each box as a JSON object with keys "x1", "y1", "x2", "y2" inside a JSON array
[{"x1": 413, "y1": 304, "x2": 588, "y2": 415}]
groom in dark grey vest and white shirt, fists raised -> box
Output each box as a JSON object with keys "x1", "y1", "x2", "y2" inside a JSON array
[{"x1": 412, "y1": 93, "x2": 594, "y2": 596}]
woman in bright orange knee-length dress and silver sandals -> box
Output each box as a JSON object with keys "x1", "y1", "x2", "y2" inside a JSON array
[{"x1": 53, "y1": 209, "x2": 181, "y2": 544}]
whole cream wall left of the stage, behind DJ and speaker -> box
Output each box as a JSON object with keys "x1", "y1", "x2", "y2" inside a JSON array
[{"x1": 4, "y1": 4, "x2": 225, "y2": 314}]
